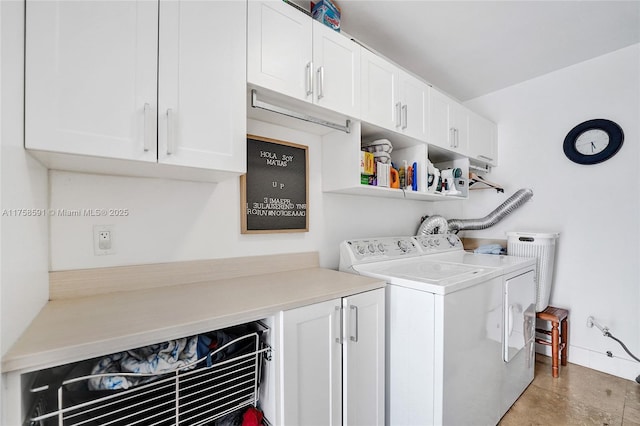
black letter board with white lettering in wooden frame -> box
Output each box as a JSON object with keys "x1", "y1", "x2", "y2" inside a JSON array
[{"x1": 240, "y1": 135, "x2": 309, "y2": 234}]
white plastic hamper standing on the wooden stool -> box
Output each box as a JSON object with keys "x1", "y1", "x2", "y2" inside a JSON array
[{"x1": 507, "y1": 232, "x2": 560, "y2": 312}]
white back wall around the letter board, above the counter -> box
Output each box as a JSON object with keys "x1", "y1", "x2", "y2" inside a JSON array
[{"x1": 50, "y1": 116, "x2": 461, "y2": 270}]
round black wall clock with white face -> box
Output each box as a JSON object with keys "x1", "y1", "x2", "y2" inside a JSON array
[{"x1": 563, "y1": 118, "x2": 624, "y2": 164}]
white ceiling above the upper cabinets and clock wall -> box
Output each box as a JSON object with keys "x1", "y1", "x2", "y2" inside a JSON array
[{"x1": 330, "y1": 0, "x2": 640, "y2": 101}]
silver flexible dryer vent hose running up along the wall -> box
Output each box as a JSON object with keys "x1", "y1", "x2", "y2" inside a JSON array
[{"x1": 418, "y1": 188, "x2": 533, "y2": 235}]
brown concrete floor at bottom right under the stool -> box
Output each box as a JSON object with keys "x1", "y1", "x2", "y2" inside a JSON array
[{"x1": 498, "y1": 354, "x2": 640, "y2": 426}]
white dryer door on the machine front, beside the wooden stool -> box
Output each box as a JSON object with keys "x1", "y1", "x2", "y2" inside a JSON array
[{"x1": 502, "y1": 271, "x2": 536, "y2": 362}]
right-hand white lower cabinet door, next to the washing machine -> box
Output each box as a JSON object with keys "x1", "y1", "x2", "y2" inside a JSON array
[{"x1": 343, "y1": 289, "x2": 385, "y2": 426}]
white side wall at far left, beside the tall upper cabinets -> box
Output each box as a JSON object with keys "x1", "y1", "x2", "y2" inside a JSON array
[{"x1": 0, "y1": 1, "x2": 49, "y2": 354}]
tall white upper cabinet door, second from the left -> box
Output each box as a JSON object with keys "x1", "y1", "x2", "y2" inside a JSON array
[{"x1": 158, "y1": 0, "x2": 247, "y2": 172}]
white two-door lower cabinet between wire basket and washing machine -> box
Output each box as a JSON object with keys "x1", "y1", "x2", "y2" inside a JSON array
[{"x1": 280, "y1": 289, "x2": 385, "y2": 426}]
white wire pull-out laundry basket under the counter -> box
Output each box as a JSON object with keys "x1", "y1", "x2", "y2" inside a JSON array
[{"x1": 28, "y1": 333, "x2": 271, "y2": 426}]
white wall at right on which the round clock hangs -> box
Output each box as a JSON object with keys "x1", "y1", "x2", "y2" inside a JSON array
[{"x1": 464, "y1": 45, "x2": 640, "y2": 379}]
